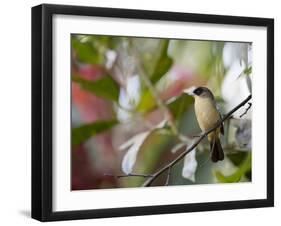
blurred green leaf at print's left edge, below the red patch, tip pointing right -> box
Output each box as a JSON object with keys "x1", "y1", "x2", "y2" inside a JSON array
[{"x1": 72, "y1": 119, "x2": 118, "y2": 146}]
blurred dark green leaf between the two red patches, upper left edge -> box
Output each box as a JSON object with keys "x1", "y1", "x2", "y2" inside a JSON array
[{"x1": 72, "y1": 75, "x2": 119, "y2": 101}]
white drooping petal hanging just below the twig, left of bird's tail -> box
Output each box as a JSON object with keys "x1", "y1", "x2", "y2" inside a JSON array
[{"x1": 182, "y1": 147, "x2": 197, "y2": 182}]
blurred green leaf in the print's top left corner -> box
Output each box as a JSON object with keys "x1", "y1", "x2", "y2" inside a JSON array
[{"x1": 71, "y1": 37, "x2": 104, "y2": 65}]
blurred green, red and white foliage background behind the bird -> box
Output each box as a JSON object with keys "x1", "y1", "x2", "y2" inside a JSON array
[{"x1": 71, "y1": 34, "x2": 252, "y2": 190}]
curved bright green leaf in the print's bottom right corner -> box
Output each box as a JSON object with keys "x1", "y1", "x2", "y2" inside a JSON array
[{"x1": 215, "y1": 152, "x2": 252, "y2": 183}]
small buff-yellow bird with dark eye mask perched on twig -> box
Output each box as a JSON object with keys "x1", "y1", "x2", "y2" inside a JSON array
[{"x1": 185, "y1": 86, "x2": 224, "y2": 162}]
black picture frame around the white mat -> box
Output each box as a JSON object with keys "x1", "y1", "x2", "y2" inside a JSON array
[{"x1": 32, "y1": 4, "x2": 274, "y2": 221}]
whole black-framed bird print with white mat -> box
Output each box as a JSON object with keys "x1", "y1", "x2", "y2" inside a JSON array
[{"x1": 32, "y1": 4, "x2": 274, "y2": 221}]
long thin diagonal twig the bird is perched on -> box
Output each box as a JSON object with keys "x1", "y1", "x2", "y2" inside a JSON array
[{"x1": 142, "y1": 95, "x2": 252, "y2": 187}]
